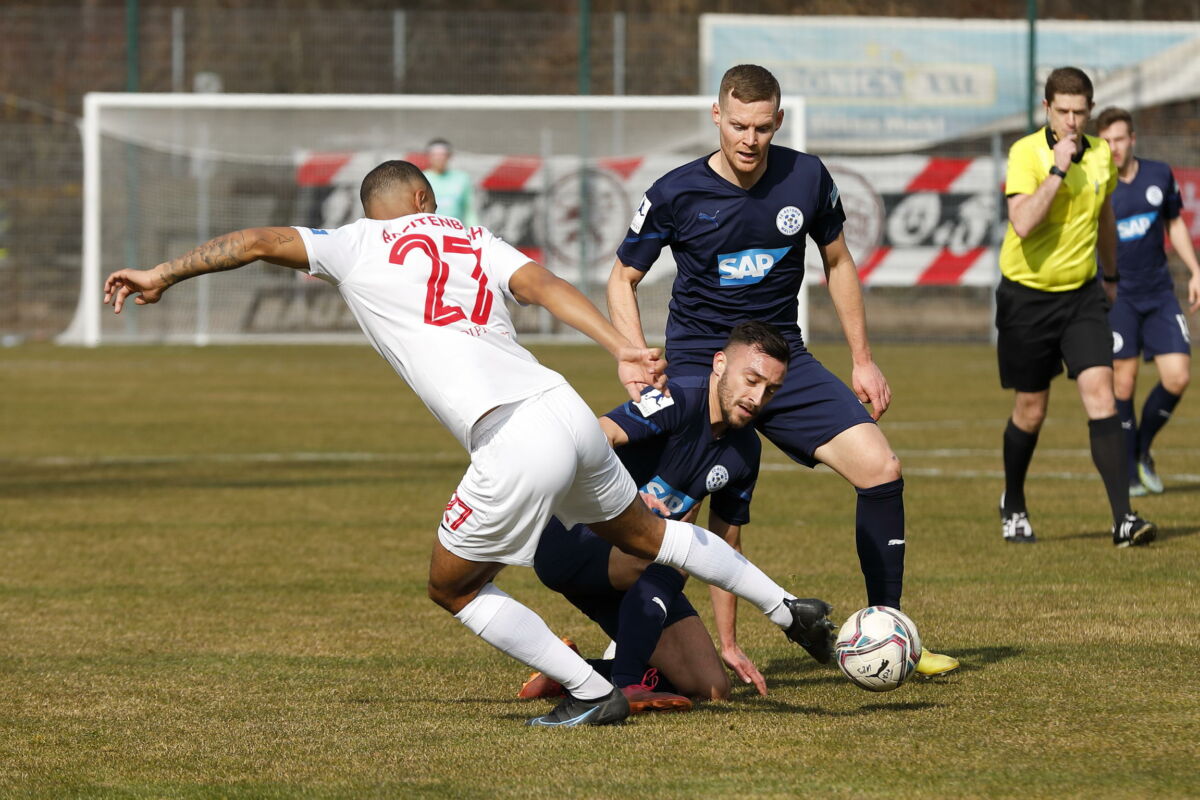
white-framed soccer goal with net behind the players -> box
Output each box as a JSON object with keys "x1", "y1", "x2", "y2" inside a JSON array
[{"x1": 58, "y1": 92, "x2": 818, "y2": 347}]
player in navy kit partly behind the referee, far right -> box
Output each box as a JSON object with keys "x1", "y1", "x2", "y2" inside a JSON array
[{"x1": 1097, "y1": 108, "x2": 1200, "y2": 497}]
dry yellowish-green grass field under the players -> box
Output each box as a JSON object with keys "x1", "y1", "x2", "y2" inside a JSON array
[{"x1": 0, "y1": 345, "x2": 1200, "y2": 799}]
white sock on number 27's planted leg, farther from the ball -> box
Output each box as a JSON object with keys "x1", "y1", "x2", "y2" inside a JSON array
[{"x1": 455, "y1": 583, "x2": 612, "y2": 700}]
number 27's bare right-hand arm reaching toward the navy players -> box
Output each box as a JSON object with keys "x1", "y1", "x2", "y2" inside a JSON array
[{"x1": 509, "y1": 261, "x2": 667, "y2": 399}]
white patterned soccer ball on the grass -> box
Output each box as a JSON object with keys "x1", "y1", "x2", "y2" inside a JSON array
[{"x1": 834, "y1": 606, "x2": 920, "y2": 692}]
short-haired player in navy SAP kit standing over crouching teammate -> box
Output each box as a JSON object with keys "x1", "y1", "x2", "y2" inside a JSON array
[{"x1": 608, "y1": 65, "x2": 958, "y2": 674}]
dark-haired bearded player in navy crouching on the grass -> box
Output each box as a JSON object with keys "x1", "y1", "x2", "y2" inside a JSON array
[{"x1": 520, "y1": 321, "x2": 788, "y2": 714}]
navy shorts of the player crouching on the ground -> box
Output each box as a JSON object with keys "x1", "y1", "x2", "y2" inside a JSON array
[{"x1": 533, "y1": 517, "x2": 697, "y2": 639}]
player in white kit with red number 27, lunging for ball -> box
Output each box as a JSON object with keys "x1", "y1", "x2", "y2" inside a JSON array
[{"x1": 104, "y1": 161, "x2": 833, "y2": 726}]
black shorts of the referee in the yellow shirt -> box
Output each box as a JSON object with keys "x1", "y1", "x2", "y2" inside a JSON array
[{"x1": 996, "y1": 277, "x2": 1112, "y2": 392}]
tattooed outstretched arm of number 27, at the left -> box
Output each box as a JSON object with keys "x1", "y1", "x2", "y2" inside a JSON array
[{"x1": 104, "y1": 228, "x2": 308, "y2": 314}]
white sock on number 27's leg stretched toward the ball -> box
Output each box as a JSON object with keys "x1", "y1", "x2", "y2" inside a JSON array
[{"x1": 654, "y1": 519, "x2": 794, "y2": 627}]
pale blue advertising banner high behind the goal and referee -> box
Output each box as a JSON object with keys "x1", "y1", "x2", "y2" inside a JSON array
[{"x1": 701, "y1": 14, "x2": 1200, "y2": 152}]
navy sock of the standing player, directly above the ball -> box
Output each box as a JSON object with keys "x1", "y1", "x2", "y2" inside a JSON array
[{"x1": 854, "y1": 477, "x2": 904, "y2": 609}]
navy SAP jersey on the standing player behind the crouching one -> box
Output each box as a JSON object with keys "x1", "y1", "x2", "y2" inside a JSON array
[{"x1": 617, "y1": 145, "x2": 846, "y2": 359}]
